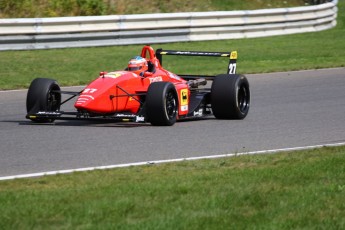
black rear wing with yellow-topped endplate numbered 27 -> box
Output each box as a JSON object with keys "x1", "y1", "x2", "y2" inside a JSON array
[{"x1": 156, "y1": 49, "x2": 237, "y2": 77}]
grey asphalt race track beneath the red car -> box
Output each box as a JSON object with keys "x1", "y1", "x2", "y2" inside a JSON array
[{"x1": 0, "y1": 68, "x2": 345, "y2": 177}]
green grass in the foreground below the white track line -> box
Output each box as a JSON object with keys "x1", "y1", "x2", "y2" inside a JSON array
[{"x1": 0, "y1": 147, "x2": 345, "y2": 229}]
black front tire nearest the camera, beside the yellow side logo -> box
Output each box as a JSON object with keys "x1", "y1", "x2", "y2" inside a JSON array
[{"x1": 146, "y1": 82, "x2": 178, "y2": 126}]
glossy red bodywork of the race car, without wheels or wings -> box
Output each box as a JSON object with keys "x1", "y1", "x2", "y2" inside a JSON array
[{"x1": 74, "y1": 46, "x2": 190, "y2": 116}]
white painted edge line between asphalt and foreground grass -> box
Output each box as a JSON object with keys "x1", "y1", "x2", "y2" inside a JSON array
[{"x1": 0, "y1": 142, "x2": 345, "y2": 181}]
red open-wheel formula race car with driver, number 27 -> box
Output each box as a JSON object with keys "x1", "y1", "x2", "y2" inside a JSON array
[{"x1": 26, "y1": 45, "x2": 250, "y2": 126}]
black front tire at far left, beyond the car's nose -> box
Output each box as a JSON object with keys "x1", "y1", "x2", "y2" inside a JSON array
[{"x1": 26, "y1": 78, "x2": 61, "y2": 122}]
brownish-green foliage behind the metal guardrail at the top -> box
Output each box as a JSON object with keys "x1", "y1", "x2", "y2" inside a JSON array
[{"x1": 0, "y1": 0, "x2": 310, "y2": 18}]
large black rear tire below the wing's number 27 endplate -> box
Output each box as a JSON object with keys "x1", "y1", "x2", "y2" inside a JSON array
[{"x1": 211, "y1": 74, "x2": 250, "y2": 119}]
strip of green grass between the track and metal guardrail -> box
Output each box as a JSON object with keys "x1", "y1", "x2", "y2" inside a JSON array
[{"x1": 0, "y1": 1, "x2": 345, "y2": 89}]
